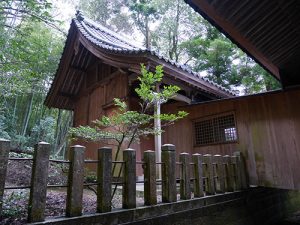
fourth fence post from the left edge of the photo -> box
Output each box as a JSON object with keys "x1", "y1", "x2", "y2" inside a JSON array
[{"x1": 97, "y1": 147, "x2": 112, "y2": 213}]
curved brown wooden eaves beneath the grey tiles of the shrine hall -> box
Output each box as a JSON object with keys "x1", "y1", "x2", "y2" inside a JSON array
[{"x1": 45, "y1": 16, "x2": 234, "y2": 110}]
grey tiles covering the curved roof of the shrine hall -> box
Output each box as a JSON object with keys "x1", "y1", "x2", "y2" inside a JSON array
[{"x1": 74, "y1": 11, "x2": 236, "y2": 96}]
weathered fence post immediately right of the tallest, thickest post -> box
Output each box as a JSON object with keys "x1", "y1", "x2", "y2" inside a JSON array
[{"x1": 179, "y1": 152, "x2": 191, "y2": 200}]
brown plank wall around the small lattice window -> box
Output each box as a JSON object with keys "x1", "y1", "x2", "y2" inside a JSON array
[{"x1": 163, "y1": 90, "x2": 300, "y2": 189}]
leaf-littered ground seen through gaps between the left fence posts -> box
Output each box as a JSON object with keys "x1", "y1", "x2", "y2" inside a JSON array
[{"x1": 0, "y1": 156, "x2": 143, "y2": 225}]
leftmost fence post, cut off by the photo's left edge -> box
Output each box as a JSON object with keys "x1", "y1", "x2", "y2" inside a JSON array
[{"x1": 0, "y1": 139, "x2": 10, "y2": 217}]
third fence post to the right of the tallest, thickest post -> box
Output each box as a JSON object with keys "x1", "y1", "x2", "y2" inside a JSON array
[{"x1": 203, "y1": 154, "x2": 216, "y2": 195}]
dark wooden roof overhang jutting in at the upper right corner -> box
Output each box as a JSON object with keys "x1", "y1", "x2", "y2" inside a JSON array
[{"x1": 185, "y1": 0, "x2": 300, "y2": 87}]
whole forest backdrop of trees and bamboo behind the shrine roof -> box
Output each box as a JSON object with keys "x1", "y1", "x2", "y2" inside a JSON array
[{"x1": 0, "y1": 0, "x2": 280, "y2": 155}]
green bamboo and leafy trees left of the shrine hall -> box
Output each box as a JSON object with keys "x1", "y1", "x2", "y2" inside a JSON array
[{"x1": 0, "y1": 0, "x2": 68, "y2": 153}]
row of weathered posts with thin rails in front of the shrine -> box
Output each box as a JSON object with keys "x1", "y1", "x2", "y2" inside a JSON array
[{"x1": 0, "y1": 140, "x2": 247, "y2": 222}]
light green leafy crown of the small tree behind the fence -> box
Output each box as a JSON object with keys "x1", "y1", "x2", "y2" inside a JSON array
[{"x1": 70, "y1": 64, "x2": 187, "y2": 156}]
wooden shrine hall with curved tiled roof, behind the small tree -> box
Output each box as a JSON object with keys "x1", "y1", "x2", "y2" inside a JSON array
[{"x1": 45, "y1": 13, "x2": 235, "y2": 174}]
